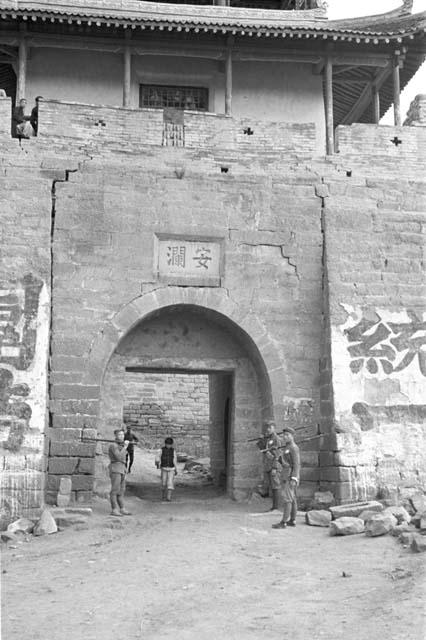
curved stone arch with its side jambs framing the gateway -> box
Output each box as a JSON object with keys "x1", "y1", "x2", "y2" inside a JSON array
[{"x1": 86, "y1": 287, "x2": 283, "y2": 499}]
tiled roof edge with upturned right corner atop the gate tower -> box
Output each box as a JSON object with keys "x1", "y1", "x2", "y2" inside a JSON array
[{"x1": 0, "y1": 0, "x2": 426, "y2": 41}]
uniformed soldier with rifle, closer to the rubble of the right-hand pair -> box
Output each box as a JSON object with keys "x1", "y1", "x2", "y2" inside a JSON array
[{"x1": 272, "y1": 427, "x2": 300, "y2": 529}]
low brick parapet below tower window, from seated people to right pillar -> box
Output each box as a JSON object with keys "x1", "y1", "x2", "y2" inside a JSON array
[{"x1": 35, "y1": 100, "x2": 315, "y2": 156}]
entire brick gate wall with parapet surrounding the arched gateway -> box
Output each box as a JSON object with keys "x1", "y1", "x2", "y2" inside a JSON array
[{"x1": 0, "y1": 95, "x2": 426, "y2": 524}]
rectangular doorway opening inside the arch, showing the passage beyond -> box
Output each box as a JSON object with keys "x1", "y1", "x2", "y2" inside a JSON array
[{"x1": 123, "y1": 367, "x2": 233, "y2": 500}]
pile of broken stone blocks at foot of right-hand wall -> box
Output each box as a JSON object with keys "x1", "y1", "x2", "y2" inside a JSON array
[{"x1": 305, "y1": 493, "x2": 426, "y2": 553}]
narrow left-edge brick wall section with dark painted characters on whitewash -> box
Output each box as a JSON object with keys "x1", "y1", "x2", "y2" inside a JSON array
[{"x1": 0, "y1": 99, "x2": 52, "y2": 527}]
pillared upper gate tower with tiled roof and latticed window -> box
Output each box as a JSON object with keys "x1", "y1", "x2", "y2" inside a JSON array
[{"x1": 0, "y1": 0, "x2": 426, "y2": 153}]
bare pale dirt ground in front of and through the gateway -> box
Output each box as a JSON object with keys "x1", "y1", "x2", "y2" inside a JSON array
[{"x1": 1, "y1": 457, "x2": 426, "y2": 640}]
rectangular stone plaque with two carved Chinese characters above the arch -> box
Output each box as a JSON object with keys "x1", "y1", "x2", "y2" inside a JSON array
[{"x1": 158, "y1": 238, "x2": 221, "y2": 281}]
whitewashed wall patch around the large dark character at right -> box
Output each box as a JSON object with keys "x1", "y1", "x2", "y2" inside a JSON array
[{"x1": 332, "y1": 305, "x2": 426, "y2": 500}]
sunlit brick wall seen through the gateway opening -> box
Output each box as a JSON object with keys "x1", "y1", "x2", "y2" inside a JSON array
[{"x1": 123, "y1": 372, "x2": 210, "y2": 456}]
